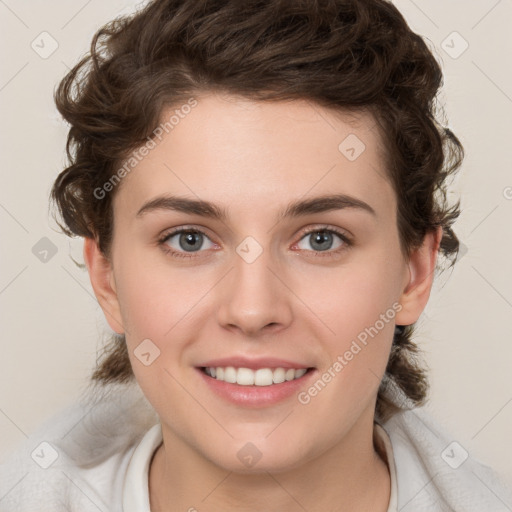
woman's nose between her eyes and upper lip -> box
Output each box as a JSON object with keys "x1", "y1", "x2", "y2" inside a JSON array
[{"x1": 217, "y1": 246, "x2": 292, "y2": 337}]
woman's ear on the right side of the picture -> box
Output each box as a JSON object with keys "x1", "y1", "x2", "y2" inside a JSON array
[{"x1": 395, "y1": 227, "x2": 443, "y2": 325}]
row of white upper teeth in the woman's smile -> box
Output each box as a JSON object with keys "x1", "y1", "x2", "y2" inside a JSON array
[{"x1": 205, "y1": 366, "x2": 307, "y2": 386}]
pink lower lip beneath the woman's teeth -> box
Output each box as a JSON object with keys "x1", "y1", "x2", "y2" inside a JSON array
[{"x1": 196, "y1": 368, "x2": 316, "y2": 407}]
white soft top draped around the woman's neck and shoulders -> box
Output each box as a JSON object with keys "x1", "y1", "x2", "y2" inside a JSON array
[{"x1": 0, "y1": 383, "x2": 512, "y2": 512}]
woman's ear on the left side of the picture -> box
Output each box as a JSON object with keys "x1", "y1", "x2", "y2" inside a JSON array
[{"x1": 84, "y1": 238, "x2": 125, "y2": 334}]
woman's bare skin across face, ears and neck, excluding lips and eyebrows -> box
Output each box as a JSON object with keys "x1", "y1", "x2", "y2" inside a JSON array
[{"x1": 84, "y1": 94, "x2": 441, "y2": 512}]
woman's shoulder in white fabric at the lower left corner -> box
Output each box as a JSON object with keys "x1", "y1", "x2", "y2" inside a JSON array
[{"x1": 0, "y1": 384, "x2": 158, "y2": 512}]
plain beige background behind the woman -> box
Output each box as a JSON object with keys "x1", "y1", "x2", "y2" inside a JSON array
[{"x1": 0, "y1": 0, "x2": 512, "y2": 483}]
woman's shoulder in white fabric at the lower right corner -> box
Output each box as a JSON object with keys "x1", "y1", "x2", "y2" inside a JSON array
[{"x1": 380, "y1": 407, "x2": 512, "y2": 512}]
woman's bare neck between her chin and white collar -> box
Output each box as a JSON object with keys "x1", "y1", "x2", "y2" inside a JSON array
[{"x1": 149, "y1": 416, "x2": 390, "y2": 512}]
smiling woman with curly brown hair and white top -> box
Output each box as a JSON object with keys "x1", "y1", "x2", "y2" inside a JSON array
[{"x1": 0, "y1": 0, "x2": 512, "y2": 512}]
